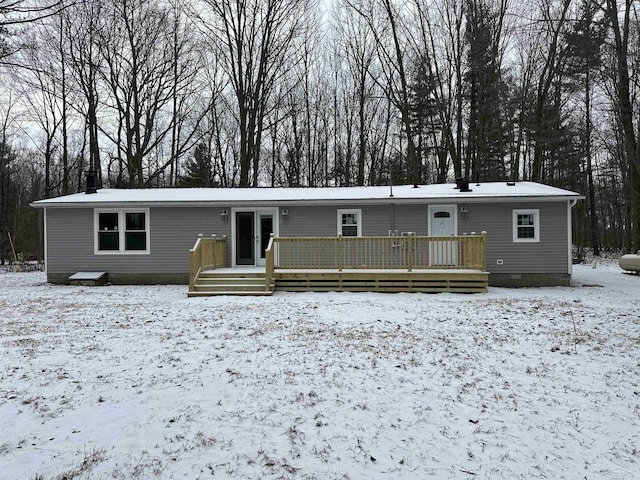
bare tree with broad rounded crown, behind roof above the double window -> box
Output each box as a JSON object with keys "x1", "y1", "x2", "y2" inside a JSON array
[{"x1": 99, "y1": 0, "x2": 202, "y2": 188}]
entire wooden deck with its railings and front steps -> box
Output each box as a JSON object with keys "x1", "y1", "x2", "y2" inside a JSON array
[{"x1": 189, "y1": 235, "x2": 489, "y2": 297}]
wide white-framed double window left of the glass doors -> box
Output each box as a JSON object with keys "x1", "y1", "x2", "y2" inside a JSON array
[{"x1": 94, "y1": 208, "x2": 149, "y2": 254}]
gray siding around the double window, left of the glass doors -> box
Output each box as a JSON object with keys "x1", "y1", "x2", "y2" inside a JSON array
[{"x1": 47, "y1": 207, "x2": 231, "y2": 274}]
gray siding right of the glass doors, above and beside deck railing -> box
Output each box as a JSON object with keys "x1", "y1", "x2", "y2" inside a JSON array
[{"x1": 266, "y1": 202, "x2": 569, "y2": 274}]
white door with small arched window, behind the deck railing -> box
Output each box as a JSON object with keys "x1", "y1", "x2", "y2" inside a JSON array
[{"x1": 429, "y1": 205, "x2": 458, "y2": 267}]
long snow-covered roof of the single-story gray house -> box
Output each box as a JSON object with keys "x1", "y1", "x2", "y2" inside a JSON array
[{"x1": 31, "y1": 182, "x2": 584, "y2": 208}]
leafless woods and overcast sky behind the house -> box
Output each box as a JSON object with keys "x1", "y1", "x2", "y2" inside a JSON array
[{"x1": 0, "y1": 0, "x2": 640, "y2": 263}]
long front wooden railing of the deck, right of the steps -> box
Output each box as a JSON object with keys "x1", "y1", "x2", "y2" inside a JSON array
[{"x1": 267, "y1": 233, "x2": 486, "y2": 271}]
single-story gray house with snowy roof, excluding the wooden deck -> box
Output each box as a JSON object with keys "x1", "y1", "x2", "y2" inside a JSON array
[{"x1": 31, "y1": 182, "x2": 583, "y2": 286}]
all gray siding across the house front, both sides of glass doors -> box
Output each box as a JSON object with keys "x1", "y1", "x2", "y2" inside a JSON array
[{"x1": 46, "y1": 200, "x2": 570, "y2": 282}]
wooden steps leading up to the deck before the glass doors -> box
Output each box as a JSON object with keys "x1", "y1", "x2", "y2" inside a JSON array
[{"x1": 189, "y1": 270, "x2": 275, "y2": 297}]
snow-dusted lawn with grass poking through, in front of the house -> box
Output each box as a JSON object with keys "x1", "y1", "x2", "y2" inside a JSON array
[{"x1": 0, "y1": 263, "x2": 640, "y2": 480}]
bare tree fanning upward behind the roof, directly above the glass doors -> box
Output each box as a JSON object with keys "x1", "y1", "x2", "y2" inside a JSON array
[{"x1": 202, "y1": 0, "x2": 309, "y2": 186}]
